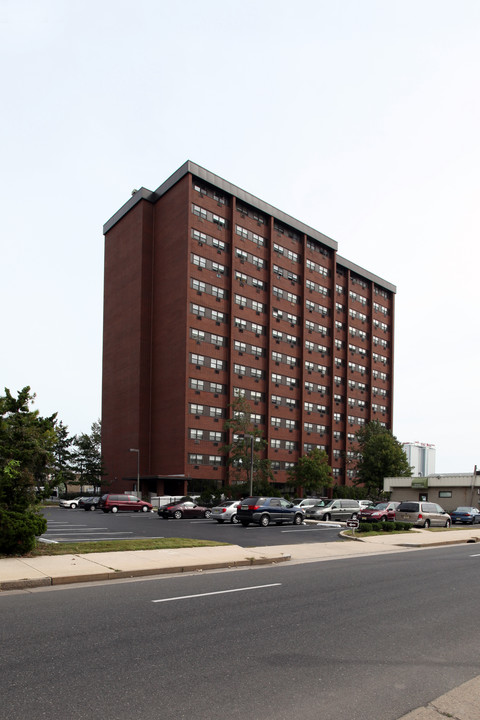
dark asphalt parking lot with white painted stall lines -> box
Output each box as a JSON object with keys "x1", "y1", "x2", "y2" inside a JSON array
[{"x1": 42, "y1": 507, "x2": 340, "y2": 547}]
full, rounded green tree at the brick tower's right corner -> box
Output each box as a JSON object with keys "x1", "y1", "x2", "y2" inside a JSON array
[{"x1": 354, "y1": 420, "x2": 412, "y2": 497}]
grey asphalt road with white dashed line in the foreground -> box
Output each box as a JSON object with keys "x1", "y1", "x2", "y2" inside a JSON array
[{"x1": 0, "y1": 544, "x2": 480, "y2": 720}]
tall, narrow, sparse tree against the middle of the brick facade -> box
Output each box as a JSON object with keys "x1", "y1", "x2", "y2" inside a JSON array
[{"x1": 222, "y1": 397, "x2": 273, "y2": 488}]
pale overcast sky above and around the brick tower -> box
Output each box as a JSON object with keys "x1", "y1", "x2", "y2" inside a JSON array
[{"x1": 0, "y1": 0, "x2": 480, "y2": 473}]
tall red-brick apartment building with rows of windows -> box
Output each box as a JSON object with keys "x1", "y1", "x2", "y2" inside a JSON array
[{"x1": 102, "y1": 162, "x2": 396, "y2": 494}]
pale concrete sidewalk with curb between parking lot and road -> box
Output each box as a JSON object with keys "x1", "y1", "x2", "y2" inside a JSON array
[{"x1": 0, "y1": 526, "x2": 480, "y2": 592}]
